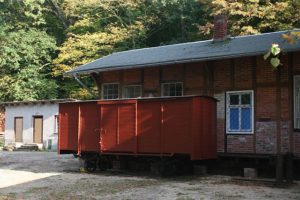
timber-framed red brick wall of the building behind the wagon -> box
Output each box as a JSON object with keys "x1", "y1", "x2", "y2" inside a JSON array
[{"x1": 96, "y1": 53, "x2": 300, "y2": 156}]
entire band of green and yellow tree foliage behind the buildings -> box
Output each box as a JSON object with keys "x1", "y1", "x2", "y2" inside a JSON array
[{"x1": 0, "y1": 0, "x2": 300, "y2": 101}]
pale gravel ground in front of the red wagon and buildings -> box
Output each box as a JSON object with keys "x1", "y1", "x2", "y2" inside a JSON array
[{"x1": 0, "y1": 152, "x2": 300, "y2": 200}]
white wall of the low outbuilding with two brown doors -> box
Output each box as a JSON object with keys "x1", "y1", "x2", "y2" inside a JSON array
[{"x1": 5, "y1": 103, "x2": 58, "y2": 150}]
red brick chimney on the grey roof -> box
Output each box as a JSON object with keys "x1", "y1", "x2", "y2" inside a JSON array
[{"x1": 213, "y1": 14, "x2": 228, "y2": 42}]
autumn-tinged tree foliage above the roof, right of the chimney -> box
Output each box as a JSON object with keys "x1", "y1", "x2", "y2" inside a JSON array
[{"x1": 199, "y1": 0, "x2": 300, "y2": 36}]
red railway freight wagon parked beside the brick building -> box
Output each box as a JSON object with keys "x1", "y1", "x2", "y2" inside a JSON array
[{"x1": 59, "y1": 96, "x2": 217, "y2": 174}]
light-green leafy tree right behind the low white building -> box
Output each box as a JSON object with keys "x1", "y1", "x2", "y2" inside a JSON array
[{"x1": 0, "y1": 27, "x2": 57, "y2": 101}]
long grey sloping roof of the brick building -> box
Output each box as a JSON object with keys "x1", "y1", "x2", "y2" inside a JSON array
[{"x1": 66, "y1": 31, "x2": 300, "y2": 75}]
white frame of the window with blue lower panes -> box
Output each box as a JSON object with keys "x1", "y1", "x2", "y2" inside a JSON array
[{"x1": 225, "y1": 90, "x2": 254, "y2": 134}]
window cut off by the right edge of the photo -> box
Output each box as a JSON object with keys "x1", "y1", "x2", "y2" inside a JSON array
[{"x1": 294, "y1": 75, "x2": 300, "y2": 129}]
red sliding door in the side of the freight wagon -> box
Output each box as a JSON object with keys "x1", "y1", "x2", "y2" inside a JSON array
[{"x1": 100, "y1": 101, "x2": 137, "y2": 152}]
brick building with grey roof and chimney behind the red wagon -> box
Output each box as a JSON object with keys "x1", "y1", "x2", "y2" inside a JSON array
[{"x1": 67, "y1": 17, "x2": 300, "y2": 178}]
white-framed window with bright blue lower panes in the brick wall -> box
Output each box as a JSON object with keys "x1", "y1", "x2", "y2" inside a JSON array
[{"x1": 226, "y1": 91, "x2": 253, "y2": 133}]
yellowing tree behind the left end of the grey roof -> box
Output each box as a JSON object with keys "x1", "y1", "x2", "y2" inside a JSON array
[{"x1": 53, "y1": 0, "x2": 149, "y2": 98}]
